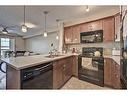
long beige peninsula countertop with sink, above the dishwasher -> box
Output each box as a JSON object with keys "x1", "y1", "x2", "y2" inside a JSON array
[{"x1": 1, "y1": 54, "x2": 77, "y2": 70}]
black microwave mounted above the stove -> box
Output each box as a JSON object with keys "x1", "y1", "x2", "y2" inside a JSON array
[{"x1": 80, "y1": 30, "x2": 103, "y2": 43}]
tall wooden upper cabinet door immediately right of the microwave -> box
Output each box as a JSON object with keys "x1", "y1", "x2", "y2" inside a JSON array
[{"x1": 103, "y1": 17, "x2": 115, "y2": 42}]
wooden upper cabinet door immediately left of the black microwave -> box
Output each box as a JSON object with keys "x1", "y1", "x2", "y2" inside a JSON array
[{"x1": 72, "y1": 25, "x2": 80, "y2": 43}]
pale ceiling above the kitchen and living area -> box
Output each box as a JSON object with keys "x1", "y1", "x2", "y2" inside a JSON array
[{"x1": 0, "y1": 5, "x2": 119, "y2": 36}]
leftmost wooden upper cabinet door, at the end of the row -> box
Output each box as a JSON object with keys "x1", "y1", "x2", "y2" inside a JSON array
[{"x1": 64, "y1": 27, "x2": 73, "y2": 44}]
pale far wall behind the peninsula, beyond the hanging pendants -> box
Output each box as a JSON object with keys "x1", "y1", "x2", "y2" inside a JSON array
[{"x1": 25, "y1": 32, "x2": 59, "y2": 54}]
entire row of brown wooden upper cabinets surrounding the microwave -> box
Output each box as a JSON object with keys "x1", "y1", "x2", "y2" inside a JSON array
[{"x1": 64, "y1": 16, "x2": 115, "y2": 44}]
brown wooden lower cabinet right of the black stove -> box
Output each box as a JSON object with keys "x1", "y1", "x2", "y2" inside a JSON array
[{"x1": 104, "y1": 58, "x2": 121, "y2": 89}]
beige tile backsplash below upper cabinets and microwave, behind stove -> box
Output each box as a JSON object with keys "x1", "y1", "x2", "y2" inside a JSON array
[{"x1": 67, "y1": 42, "x2": 120, "y2": 55}]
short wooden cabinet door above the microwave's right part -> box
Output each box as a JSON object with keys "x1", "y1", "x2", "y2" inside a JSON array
[{"x1": 88, "y1": 20, "x2": 102, "y2": 31}]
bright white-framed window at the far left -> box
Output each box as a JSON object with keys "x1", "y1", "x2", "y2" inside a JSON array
[{"x1": 1, "y1": 38, "x2": 10, "y2": 50}]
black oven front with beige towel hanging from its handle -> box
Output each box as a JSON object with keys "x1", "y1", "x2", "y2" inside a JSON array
[{"x1": 78, "y1": 56, "x2": 104, "y2": 86}]
